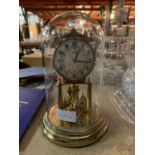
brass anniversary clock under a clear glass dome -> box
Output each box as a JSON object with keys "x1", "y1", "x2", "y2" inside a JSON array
[{"x1": 43, "y1": 12, "x2": 107, "y2": 147}]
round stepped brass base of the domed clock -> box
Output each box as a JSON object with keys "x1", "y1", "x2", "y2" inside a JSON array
[{"x1": 42, "y1": 105, "x2": 108, "y2": 147}]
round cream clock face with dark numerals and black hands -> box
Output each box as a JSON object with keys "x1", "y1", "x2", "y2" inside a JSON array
[{"x1": 53, "y1": 38, "x2": 95, "y2": 81}]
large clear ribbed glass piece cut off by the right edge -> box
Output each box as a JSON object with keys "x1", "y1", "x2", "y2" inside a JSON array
[{"x1": 113, "y1": 42, "x2": 135, "y2": 125}]
